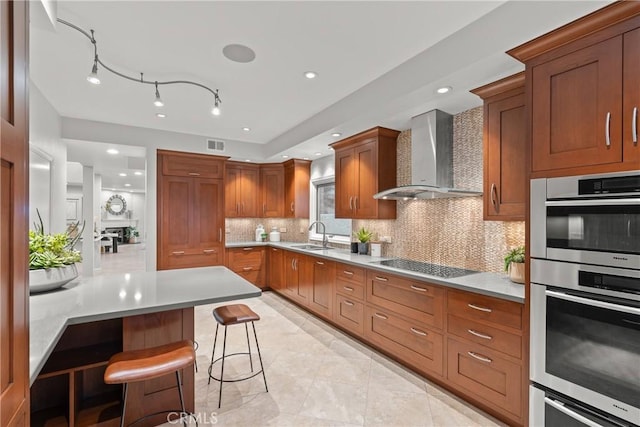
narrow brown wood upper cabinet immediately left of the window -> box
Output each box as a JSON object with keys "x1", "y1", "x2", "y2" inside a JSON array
[{"x1": 284, "y1": 159, "x2": 311, "y2": 218}]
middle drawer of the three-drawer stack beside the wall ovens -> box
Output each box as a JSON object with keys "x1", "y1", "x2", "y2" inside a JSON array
[{"x1": 447, "y1": 314, "x2": 522, "y2": 359}]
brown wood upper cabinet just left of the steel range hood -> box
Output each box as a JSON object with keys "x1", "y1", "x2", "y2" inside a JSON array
[{"x1": 331, "y1": 127, "x2": 400, "y2": 219}]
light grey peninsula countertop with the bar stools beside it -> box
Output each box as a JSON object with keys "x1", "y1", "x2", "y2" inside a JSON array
[{"x1": 29, "y1": 267, "x2": 261, "y2": 384}]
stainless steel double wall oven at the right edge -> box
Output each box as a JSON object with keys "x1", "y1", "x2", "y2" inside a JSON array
[{"x1": 529, "y1": 171, "x2": 640, "y2": 427}]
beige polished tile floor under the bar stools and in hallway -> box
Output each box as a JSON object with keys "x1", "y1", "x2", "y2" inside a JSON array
[{"x1": 98, "y1": 244, "x2": 504, "y2": 427}]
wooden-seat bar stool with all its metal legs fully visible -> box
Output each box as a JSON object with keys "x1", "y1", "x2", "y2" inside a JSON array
[{"x1": 208, "y1": 304, "x2": 269, "y2": 408}]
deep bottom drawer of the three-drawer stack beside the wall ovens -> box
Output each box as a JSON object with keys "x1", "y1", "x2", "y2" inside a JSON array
[{"x1": 447, "y1": 338, "x2": 522, "y2": 417}]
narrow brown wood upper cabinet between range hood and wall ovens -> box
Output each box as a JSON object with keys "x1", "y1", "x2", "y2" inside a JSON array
[{"x1": 471, "y1": 73, "x2": 527, "y2": 221}]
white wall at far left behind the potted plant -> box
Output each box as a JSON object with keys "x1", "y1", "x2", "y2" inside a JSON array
[{"x1": 29, "y1": 81, "x2": 67, "y2": 233}]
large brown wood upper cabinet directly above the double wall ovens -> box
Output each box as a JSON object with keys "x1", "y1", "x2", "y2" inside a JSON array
[{"x1": 508, "y1": 2, "x2": 640, "y2": 177}]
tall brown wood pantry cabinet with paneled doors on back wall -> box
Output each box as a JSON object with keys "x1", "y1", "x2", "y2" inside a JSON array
[{"x1": 157, "y1": 150, "x2": 227, "y2": 270}]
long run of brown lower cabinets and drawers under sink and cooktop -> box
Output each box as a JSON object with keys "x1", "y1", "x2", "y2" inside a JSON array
[{"x1": 272, "y1": 251, "x2": 527, "y2": 425}]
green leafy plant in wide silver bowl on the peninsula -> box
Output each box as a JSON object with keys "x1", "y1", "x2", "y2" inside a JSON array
[{"x1": 29, "y1": 212, "x2": 84, "y2": 293}]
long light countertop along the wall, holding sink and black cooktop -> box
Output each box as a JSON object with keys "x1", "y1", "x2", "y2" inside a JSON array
[{"x1": 226, "y1": 242, "x2": 524, "y2": 304}]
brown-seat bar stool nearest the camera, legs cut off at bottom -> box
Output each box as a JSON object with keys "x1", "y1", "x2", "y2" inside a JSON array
[{"x1": 104, "y1": 340, "x2": 196, "y2": 427}]
